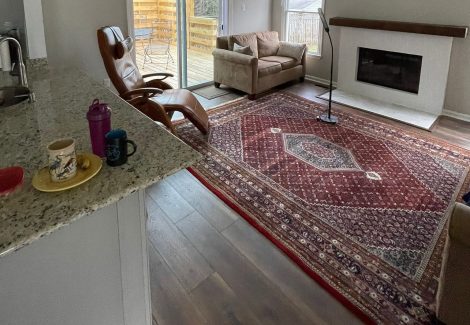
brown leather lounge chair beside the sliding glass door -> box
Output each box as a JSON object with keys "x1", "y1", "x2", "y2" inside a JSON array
[{"x1": 97, "y1": 26, "x2": 209, "y2": 134}]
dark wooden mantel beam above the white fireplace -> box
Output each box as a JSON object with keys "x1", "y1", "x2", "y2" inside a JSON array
[{"x1": 330, "y1": 17, "x2": 468, "y2": 38}]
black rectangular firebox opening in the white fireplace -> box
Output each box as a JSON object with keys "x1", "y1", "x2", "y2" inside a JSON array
[{"x1": 357, "y1": 47, "x2": 423, "y2": 94}]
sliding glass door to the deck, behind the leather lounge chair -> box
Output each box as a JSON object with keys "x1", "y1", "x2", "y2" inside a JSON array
[{"x1": 129, "y1": 0, "x2": 228, "y2": 88}]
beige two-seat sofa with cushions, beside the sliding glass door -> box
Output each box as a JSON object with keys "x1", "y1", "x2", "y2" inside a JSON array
[{"x1": 212, "y1": 31, "x2": 306, "y2": 99}]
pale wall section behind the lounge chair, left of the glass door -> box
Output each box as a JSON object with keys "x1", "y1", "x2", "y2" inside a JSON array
[{"x1": 42, "y1": 0, "x2": 127, "y2": 82}]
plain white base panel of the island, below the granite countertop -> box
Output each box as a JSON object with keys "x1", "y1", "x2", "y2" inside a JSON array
[{"x1": 0, "y1": 190, "x2": 152, "y2": 325}]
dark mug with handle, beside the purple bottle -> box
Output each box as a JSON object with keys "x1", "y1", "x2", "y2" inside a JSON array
[{"x1": 106, "y1": 129, "x2": 137, "y2": 167}]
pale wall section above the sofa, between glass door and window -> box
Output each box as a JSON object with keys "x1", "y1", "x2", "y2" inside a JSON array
[{"x1": 229, "y1": 0, "x2": 272, "y2": 34}]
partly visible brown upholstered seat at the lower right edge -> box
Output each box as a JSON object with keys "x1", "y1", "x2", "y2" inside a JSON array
[{"x1": 436, "y1": 203, "x2": 470, "y2": 325}]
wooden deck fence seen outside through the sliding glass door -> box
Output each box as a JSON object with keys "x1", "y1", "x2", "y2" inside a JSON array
[{"x1": 134, "y1": 0, "x2": 218, "y2": 53}]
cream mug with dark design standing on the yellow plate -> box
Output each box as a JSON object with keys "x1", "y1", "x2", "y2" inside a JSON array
[{"x1": 47, "y1": 139, "x2": 77, "y2": 182}]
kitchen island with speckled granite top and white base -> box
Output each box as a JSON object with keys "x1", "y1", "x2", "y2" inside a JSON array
[{"x1": 0, "y1": 67, "x2": 200, "y2": 325}]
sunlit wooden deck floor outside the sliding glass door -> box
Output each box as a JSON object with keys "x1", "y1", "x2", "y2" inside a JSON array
[{"x1": 136, "y1": 46, "x2": 214, "y2": 88}]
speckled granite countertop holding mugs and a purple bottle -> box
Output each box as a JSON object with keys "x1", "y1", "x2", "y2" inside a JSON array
[{"x1": 0, "y1": 64, "x2": 200, "y2": 257}]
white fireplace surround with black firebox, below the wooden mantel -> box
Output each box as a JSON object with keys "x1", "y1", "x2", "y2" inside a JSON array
[{"x1": 333, "y1": 27, "x2": 453, "y2": 119}]
